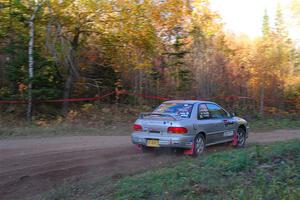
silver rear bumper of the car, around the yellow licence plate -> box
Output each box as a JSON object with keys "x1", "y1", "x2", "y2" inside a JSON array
[{"x1": 131, "y1": 132, "x2": 194, "y2": 149}]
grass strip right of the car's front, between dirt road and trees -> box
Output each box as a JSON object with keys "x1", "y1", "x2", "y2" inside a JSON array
[{"x1": 249, "y1": 118, "x2": 300, "y2": 132}]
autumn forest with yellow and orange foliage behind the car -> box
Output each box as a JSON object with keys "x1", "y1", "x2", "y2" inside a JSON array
[{"x1": 0, "y1": 0, "x2": 300, "y2": 119}]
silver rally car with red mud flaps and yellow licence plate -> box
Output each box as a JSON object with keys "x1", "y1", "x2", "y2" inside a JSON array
[{"x1": 131, "y1": 100, "x2": 249, "y2": 156}]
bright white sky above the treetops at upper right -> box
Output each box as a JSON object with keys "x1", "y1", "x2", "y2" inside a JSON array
[{"x1": 211, "y1": 0, "x2": 299, "y2": 39}]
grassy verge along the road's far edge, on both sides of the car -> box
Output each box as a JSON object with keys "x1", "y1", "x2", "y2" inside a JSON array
[{"x1": 0, "y1": 118, "x2": 300, "y2": 139}]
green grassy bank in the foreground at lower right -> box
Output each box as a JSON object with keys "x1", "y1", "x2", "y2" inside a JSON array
[{"x1": 112, "y1": 140, "x2": 300, "y2": 200}]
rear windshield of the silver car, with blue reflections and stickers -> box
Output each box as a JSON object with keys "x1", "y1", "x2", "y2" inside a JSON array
[{"x1": 153, "y1": 103, "x2": 193, "y2": 118}]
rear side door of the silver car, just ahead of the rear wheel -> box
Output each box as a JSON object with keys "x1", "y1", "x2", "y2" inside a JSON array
[{"x1": 197, "y1": 103, "x2": 224, "y2": 145}]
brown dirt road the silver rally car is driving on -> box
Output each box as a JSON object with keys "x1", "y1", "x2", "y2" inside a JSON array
[{"x1": 0, "y1": 130, "x2": 300, "y2": 200}]
